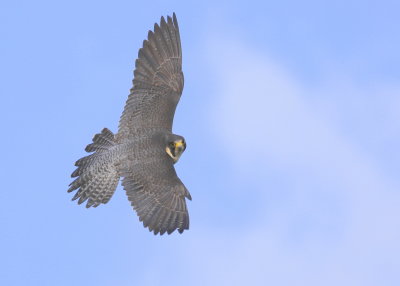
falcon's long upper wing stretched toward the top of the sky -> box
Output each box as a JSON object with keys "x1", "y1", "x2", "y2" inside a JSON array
[{"x1": 118, "y1": 13, "x2": 183, "y2": 138}]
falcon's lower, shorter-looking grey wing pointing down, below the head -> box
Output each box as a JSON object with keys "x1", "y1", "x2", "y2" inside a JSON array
[{"x1": 121, "y1": 154, "x2": 192, "y2": 235}]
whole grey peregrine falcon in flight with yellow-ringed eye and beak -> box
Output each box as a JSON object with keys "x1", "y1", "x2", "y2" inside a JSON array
[{"x1": 68, "y1": 13, "x2": 191, "y2": 235}]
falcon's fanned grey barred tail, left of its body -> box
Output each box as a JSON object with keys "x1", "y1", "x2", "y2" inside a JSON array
[{"x1": 68, "y1": 128, "x2": 119, "y2": 208}]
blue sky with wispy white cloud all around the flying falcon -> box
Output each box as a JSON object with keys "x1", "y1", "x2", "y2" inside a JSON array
[{"x1": 0, "y1": 1, "x2": 400, "y2": 285}]
